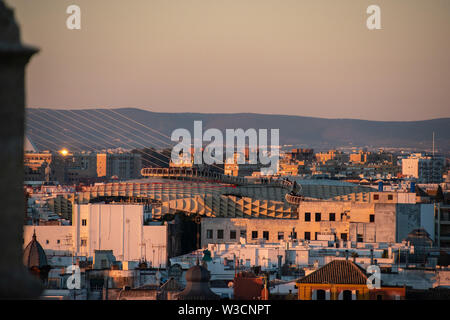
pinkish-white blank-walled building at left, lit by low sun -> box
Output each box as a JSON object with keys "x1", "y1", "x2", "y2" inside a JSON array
[{"x1": 24, "y1": 204, "x2": 168, "y2": 268}]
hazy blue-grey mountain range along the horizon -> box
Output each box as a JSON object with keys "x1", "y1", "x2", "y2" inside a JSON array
[{"x1": 26, "y1": 108, "x2": 450, "y2": 152}]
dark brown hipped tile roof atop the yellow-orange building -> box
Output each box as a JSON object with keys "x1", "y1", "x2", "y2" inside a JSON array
[{"x1": 297, "y1": 260, "x2": 367, "y2": 284}]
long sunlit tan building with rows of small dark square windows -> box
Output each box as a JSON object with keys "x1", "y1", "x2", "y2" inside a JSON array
[{"x1": 201, "y1": 192, "x2": 435, "y2": 245}]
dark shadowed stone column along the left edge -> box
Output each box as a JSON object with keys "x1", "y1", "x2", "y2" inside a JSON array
[{"x1": 0, "y1": 0, "x2": 42, "y2": 299}]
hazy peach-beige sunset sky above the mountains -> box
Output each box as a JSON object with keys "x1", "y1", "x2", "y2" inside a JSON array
[{"x1": 6, "y1": 0, "x2": 450, "y2": 121}]
